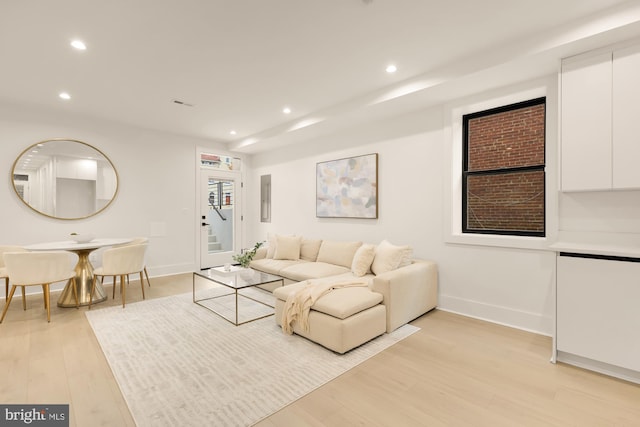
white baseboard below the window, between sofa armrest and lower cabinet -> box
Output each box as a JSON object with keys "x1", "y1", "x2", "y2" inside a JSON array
[{"x1": 438, "y1": 295, "x2": 553, "y2": 337}]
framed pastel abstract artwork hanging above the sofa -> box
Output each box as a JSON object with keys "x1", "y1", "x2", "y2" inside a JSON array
[{"x1": 316, "y1": 153, "x2": 378, "y2": 218}]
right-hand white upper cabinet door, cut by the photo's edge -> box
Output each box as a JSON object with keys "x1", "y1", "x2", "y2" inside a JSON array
[{"x1": 612, "y1": 46, "x2": 640, "y2": 189}]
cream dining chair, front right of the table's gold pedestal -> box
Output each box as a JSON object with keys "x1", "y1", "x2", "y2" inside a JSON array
[{"x1": 89, "y1": 244, "x2": 147, "y2": 309}]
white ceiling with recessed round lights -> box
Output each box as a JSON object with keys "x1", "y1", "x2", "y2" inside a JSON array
[{"x1": 0, "y1": 0, "x2": 640, "y2": 153}]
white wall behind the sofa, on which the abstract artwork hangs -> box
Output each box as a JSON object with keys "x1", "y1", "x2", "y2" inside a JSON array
[{"x1": 245, "y1": 88, "x2": 555, "y2": 335}]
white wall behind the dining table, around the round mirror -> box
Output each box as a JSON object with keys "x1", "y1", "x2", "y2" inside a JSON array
[{"x1": 0, "y1": 98, "x2": 225, "y2": 282}]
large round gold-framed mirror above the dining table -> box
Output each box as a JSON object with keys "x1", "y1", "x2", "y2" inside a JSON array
[{"x1": 11, "y1": 138, "x2": 119, "y2": 220}]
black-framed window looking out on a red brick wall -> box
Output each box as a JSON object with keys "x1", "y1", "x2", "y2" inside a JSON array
[{"x1": 462, "y1": 97, "x2": 546, "y2": 237}]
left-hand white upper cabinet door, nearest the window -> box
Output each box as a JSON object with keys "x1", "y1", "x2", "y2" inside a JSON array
[{"x1": 561, "y1": 52, "x2": 612, "y2": 191}]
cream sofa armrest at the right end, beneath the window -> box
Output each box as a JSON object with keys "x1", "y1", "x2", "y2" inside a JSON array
[{"x1": 371, "y1": 260, "x2": 438, "y2": 333}]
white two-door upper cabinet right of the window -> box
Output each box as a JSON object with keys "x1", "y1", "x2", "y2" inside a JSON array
[{"x1": 560, "y1": 42, "x2": 640, "y2": 191}]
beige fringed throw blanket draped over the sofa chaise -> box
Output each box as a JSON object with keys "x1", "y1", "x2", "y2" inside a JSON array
[{"x1": 282, "y1": 281, "x2": 368, "y2": 335}]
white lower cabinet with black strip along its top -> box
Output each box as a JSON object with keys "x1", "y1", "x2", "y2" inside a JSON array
[{"x1": 556, "y1": 252, "x2": 640, "y2": 382}]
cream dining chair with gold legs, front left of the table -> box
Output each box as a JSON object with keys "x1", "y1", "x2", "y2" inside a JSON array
[{"x1": 0, "y1": 251, "x2": 79, "y2": 323}]
